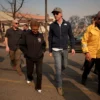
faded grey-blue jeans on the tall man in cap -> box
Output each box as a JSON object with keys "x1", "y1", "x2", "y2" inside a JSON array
[{"x1": 52, "y1": 50, "x2": 68, "y2": 87}]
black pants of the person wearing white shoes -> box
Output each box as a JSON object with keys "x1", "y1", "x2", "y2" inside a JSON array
[{"x1": 26, "y1": 58, "x2": 43, "y2": 89}]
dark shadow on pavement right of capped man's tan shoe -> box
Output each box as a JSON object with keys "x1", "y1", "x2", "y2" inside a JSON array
[{"x1": 63, "y1": 80, "x2": 91, "y2": 100}]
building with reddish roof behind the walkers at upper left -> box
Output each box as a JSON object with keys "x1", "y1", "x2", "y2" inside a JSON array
[{"x1": 0, "y1": 11, "x2": 54, "y2": 32}]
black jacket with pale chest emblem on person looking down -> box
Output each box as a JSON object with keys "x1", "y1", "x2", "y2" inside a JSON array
[{"x1": 20, "y1": 30, "x2": 46, "y2": 61}]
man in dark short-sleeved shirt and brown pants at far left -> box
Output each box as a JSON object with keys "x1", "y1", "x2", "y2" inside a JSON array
[{"x1": 5, "y1": 20, "x2": 22, "y2": 75}]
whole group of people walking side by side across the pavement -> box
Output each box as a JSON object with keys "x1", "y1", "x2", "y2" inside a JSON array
[{"x1": 5, "y1": 7, "x2": 100, "y2": 95}]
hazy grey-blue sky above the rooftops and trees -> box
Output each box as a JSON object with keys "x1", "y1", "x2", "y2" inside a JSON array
[{"x1": 0, "y1": 0, "x2": 100, "y2": 19}]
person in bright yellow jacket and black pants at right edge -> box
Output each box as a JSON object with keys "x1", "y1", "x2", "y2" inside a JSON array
[{"x1": 81, "y1": 11, "x2": 100, "y2": 94}]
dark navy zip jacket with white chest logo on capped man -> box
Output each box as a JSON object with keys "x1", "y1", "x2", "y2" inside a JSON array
[{"x1": 48, "y1": 20, "x2": 75, "y2": 52}]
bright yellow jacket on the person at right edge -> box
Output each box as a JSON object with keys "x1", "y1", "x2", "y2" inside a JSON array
[{"x1": 81, "y1": 24, "x2": 100, "y2": 58}]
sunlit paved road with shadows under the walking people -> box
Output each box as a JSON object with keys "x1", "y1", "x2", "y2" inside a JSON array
[{"x1": 0, "y1": 48, "x2": 100, "y2": 100}]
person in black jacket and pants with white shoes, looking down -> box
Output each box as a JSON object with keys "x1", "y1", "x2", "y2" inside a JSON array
[{"x1": 20, "y1": 20, "x2": 46, "y2": 93}]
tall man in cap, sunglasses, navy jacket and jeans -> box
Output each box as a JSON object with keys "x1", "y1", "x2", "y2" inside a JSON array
[{"x1": 49, "y1": 7, "x2": 75, "y2": 95}]
